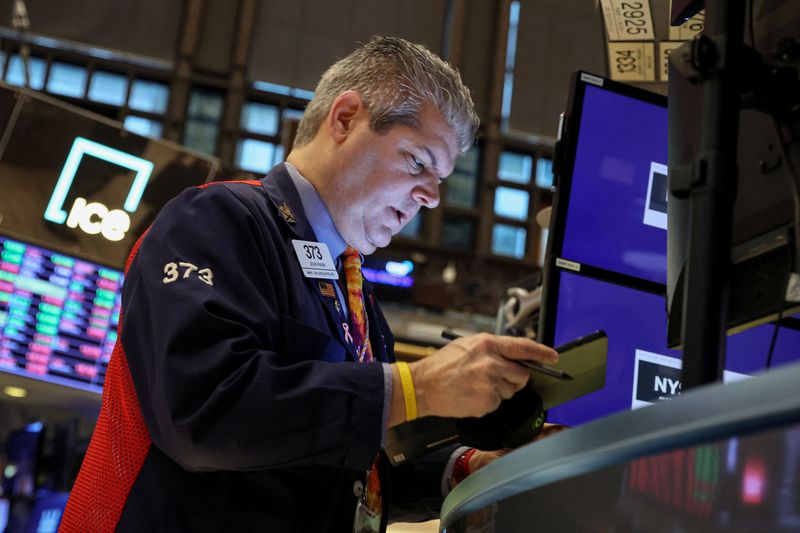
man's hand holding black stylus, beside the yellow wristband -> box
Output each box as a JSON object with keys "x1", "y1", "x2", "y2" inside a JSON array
[{"x1": 389, "y1": 333, "x2": 558, "y2": 425}]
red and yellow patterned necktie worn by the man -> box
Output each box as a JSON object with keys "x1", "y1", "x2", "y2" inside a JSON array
[{"x1": 342, "y1": 246, "x2": 383, "y2": 531}]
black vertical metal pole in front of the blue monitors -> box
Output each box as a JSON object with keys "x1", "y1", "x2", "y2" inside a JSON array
[{"x1": 681, "y1": 0, "x2": 746, "y2": 389}]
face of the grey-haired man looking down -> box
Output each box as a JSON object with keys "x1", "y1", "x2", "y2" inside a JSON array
[{"x1": 325, "y1": 104, "x2": 458, "y2": 254}]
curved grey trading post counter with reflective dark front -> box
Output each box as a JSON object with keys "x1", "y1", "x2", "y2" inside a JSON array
[{"x1": 441, "y1": 364, "x2": 800, "y2": 533}]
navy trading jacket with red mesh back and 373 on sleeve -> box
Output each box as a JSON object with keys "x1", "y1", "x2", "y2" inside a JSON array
[{"x1": 61, "y1": 165, "x2": 453, "y2": 532}]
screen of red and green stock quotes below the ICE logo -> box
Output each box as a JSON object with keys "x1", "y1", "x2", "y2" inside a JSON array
[{"x1": 0, "y1": 235, "x2": 122, "y2": 392}]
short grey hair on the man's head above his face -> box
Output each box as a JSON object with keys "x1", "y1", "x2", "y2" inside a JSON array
[{"x1": 294, "y1": 37, "x2": 480, "y2": 152}]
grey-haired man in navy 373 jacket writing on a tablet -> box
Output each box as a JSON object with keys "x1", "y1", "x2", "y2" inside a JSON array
[{"x1": 62, "y1": 38, "x2": 557, "y2": 532}]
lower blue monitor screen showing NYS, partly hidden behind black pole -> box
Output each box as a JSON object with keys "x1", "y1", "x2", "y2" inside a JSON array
[{"x1": 548, "y1": 269, "x2": 800, "y2": 425}]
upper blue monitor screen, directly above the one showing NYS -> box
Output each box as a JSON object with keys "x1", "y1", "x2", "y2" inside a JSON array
[{"x1": 554, "y1": 75, "x2": 667, "y2": 284}]
